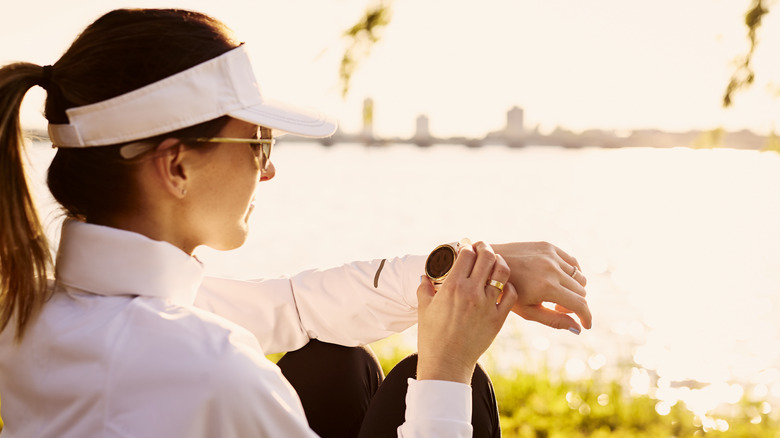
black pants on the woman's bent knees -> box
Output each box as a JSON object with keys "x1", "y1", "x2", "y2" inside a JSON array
[{"x1": 278, "y1": 339, "x2": 501, "y2": 438}]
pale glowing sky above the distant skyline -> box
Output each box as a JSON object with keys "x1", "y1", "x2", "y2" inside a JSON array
[{"x1": 0, "y1": 0, "x2": 780, "y2": 137}]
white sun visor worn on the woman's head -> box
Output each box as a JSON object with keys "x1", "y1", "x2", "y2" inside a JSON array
[{"x1": 49, "y1": 45, "x2": 336, "y2": 147}]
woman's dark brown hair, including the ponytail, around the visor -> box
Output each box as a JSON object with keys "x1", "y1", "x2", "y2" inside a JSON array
[{"x1": 0, "y1": 9, "x2": 238, "y2": 341}]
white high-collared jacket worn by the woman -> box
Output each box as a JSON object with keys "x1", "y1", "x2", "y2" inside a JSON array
[{"x1": 0, "y1": 221, "x2": 471, "y2": 438}]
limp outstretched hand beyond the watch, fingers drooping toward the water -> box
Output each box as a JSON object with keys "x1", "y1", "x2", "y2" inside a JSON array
[{"x1": 492, "y1": 242, "x2": 592, "y2": 334}]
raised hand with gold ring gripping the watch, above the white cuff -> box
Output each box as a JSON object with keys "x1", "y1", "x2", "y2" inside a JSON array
[{"x1": 417, "y1": 242, "x2": 517, "y2": 384}]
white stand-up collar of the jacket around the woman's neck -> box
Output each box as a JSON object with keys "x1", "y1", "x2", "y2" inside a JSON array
[{"x1": 55, "y1": 220, "x2": 203, "y2": 305}]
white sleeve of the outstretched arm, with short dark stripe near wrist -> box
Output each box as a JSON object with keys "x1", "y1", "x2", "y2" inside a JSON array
[{"x1": 195, "y1": 256, "x2": 425, "y2": 354}]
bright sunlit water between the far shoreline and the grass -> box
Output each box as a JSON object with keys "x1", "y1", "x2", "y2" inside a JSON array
[{"x1": 24, "y1": 142, "x2": 780, "y2": 416}]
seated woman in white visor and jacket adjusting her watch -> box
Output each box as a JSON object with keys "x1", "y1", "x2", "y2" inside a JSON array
[{"x1": 0, "y1": 10, "x2": 590, "y2": 437}]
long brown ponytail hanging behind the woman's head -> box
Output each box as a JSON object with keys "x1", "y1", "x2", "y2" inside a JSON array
[{"x1": 0, "y1": 63, "x2": 51, "y2": 342}]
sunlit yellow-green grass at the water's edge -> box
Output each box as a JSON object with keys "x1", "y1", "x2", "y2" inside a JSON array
[{"x1": 372, "y1": 343, "x2": 780, "y2": 438}]
